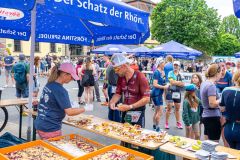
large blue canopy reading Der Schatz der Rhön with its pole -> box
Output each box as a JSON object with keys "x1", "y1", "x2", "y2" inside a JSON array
[{"x1": 0, "y1": 0, "x2": 149, "y2": 140}]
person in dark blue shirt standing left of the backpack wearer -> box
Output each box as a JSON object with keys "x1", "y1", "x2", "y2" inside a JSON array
[{"x1": 3, "y1": 53, "x2": 15, "y2": 87}]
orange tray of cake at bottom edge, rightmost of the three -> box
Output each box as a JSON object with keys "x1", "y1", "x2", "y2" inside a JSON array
[{"x1": 74, "y1": 144, "x2": 153, "y2": 160}]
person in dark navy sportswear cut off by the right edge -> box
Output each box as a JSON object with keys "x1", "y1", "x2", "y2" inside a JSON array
[{"x1": 219, "y1": 71, "x2": 240, "y2": 150}]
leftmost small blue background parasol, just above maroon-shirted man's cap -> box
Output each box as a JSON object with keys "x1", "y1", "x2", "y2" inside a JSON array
[{"x1": 92, "y1": 44, "x2": 132, "y2": 55}]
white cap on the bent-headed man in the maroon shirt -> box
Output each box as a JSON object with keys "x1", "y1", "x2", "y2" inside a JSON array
[{"x1": 111, "y1": 53, "x2": 133, "y2": 67}]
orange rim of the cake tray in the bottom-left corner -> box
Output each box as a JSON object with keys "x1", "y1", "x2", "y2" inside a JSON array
[{"x1": 0, "y1": 140, "x2": 74, "y2": 160}]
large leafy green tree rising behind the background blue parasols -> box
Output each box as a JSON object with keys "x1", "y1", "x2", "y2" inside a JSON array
[{"x1": 151, "y1": 0, "x2": 220, "y2": 54}]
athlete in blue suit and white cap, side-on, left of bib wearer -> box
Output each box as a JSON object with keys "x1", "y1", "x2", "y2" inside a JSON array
[{"x1": 151, "y1": 58, "x2": 169, "y2": 132}]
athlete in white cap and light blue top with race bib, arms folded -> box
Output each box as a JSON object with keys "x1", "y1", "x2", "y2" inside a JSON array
[{"x1": 165, "y1": 61, "x2": 184, "y2": 129}]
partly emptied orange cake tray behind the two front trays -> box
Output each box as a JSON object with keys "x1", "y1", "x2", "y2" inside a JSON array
[{"x1": 46, "y1": 134, "x2": 104, "y2": 157}]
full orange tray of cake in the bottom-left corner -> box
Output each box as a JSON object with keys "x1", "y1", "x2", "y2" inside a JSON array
[{"x1": 0, "y1": 140, "x2": 74, "y2": 160}]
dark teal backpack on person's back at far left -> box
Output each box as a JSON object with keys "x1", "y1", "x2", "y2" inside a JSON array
[{"x1": 13, "y1": 63, "x2": 27, "y2": 85}]
